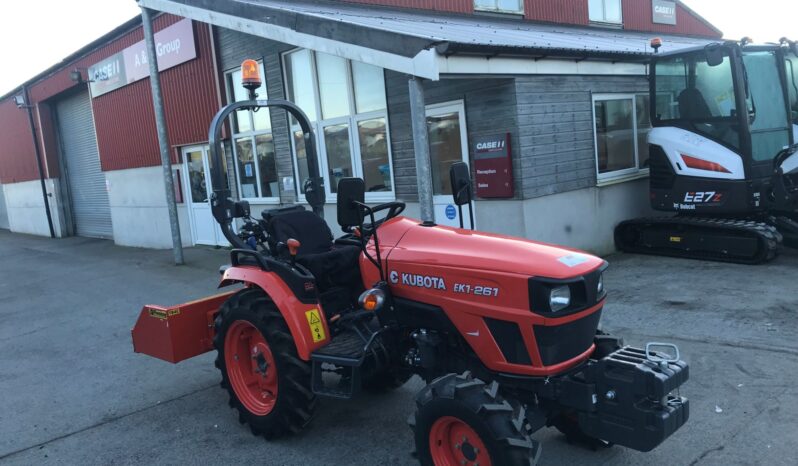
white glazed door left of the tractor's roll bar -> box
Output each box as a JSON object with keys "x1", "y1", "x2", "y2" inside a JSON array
[{"x1": 183, "y1": 146, "x2": 229, "y2": 246}]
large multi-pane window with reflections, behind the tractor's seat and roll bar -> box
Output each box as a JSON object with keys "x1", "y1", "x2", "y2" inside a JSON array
[{"x1": 283, "y1": 49, "x2": 394, "y2": 201}]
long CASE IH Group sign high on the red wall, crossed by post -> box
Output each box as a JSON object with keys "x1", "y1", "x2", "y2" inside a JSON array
[{"x1": 89, "y1": 19, "x2": 197, "y2": 97}]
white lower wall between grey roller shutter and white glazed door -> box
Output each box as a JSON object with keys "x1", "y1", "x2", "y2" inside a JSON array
[{"x1": 105, "y1": 166, "x2": 192, "y2": 249}]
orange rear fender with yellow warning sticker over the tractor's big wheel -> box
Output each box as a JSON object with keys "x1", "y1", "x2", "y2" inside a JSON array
[{"x1": 219, "y1": 267, "x2": 330, "y2": 361}]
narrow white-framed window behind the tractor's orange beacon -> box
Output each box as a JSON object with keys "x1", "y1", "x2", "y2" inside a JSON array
[{"x1": 226, "y1": 63, "x2": 280, "y2": 202}]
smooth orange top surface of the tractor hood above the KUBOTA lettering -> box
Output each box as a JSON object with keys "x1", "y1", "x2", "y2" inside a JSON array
[{"x1": 379, "y1": 219, "x2": 604, "y2": 279}]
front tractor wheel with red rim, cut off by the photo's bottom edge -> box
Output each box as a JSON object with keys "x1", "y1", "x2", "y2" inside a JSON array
[{"x1": 410, "y1": 372, "x2": 540, "y2": 466}]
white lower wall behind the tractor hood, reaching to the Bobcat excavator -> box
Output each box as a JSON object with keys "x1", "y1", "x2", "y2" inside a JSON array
[{"x1": 475, "y1": 178, "x2": 654, "y2": 255}]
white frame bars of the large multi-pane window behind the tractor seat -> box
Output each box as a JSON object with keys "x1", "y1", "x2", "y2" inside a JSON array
[{"x1": 280, "y1": 47, "x2": 396, "y2": 204}]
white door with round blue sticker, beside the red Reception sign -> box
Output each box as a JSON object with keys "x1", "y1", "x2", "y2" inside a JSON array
[{"x1": 427, "y1": 100, "x2": 474, "y2": 228}]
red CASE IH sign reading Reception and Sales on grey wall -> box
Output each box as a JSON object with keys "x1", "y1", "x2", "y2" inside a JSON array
[{"x1": 474, "y1": 133, "x2": 513, "y2": 198}]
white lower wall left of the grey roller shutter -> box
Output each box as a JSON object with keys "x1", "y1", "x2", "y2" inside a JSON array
[{"x1": 2, "y1": 178, "x2": 66, "y2": 237}]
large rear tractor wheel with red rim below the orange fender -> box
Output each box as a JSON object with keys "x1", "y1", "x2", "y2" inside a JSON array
[{"x1": 213, "y1": 288, "x2": 316, "y2": 439}]
